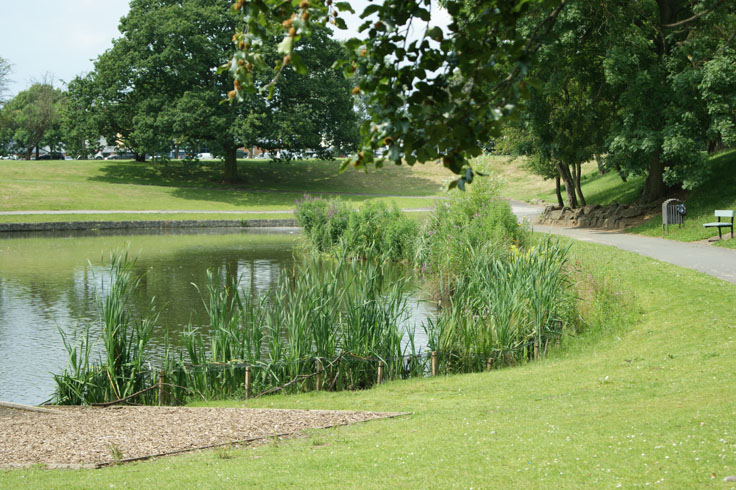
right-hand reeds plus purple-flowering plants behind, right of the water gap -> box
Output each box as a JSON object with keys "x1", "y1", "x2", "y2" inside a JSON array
[{"x1": 297, "y1": 180, "x2": 579, "y2": 373}]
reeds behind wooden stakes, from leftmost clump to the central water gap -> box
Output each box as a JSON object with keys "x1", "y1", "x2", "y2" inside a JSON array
[{"x1": 54, "y1": 255, "x2": 428, "y2": 404}]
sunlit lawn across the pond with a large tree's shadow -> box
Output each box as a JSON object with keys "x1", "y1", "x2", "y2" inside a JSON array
[{"x1": 0, "y1": 160, "x2": 451, "y2": 222}]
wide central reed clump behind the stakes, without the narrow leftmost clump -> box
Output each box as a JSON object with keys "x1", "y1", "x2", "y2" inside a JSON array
[{"x1": 167, "y1": 258, "x2": 425, "y2": 399}]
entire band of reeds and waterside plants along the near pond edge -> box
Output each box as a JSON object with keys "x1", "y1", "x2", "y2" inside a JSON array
[{"x1": 53, "y1": 181, "x2": 631, "y2": 404}]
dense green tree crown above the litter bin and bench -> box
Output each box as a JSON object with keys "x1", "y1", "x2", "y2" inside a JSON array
[{"x1": 600, "y1": 0, "x2": 736, "y2": 202}]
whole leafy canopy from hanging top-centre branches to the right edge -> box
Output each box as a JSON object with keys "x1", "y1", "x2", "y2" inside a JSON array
[{"x1": 225, "y1": 0, "x2": 736, "y2": 200}]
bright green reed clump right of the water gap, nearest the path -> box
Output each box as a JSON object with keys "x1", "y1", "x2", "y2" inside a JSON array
[{"x1": 427, "y1": 238, "x2": 577, "y2": 372}]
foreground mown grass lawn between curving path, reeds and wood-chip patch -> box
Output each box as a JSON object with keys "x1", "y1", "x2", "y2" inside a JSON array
[{"x1": 0, "y1": 237, "x2": 736, "y2": 488}]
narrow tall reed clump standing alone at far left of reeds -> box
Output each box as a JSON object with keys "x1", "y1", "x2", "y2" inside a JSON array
[{"x1": 53, "y1": 253, "x2": 158, "y2": 405}]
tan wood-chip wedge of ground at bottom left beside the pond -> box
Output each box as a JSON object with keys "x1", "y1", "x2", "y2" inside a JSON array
[{"x1": 0, "y1": 407, "x2": 401, "y2": 468}]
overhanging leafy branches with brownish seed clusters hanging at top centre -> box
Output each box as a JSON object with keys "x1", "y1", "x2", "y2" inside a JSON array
[{"x1": 224, "y1": 0, "x2": 565, "y2": 187}]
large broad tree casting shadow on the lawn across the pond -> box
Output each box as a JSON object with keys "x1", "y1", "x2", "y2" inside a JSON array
[{"x1": 74, "y1": 0, "x2": 355, "y2": 182}]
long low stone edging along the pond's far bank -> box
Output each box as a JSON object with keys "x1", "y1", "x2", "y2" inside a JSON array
[{"x1": 0, "y1": 219, "x2": 299, "y2": 233}]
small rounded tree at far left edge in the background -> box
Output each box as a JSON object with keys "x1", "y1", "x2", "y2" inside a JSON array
[{"x1": 2, "y1": 83, "x2": 64, "y2": 160}]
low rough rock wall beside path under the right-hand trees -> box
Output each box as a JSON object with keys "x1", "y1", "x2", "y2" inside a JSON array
[{"x1": 537, "y1": 203, "x2": 648, "y2": 230}]
